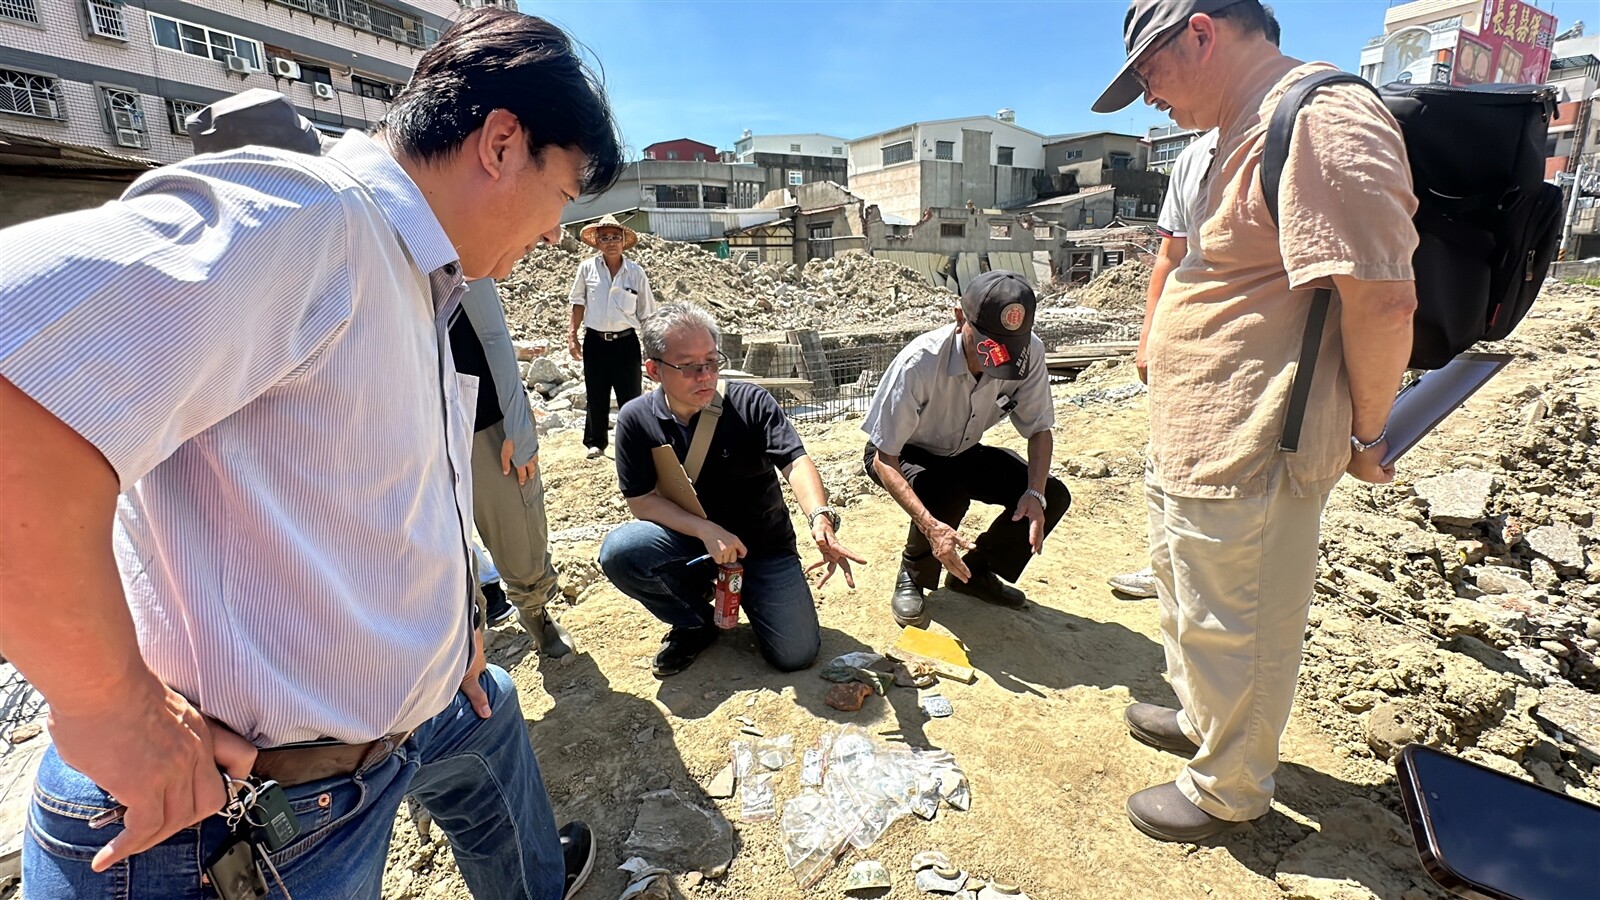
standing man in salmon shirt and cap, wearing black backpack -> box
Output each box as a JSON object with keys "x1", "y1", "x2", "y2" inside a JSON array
[{"x1": 1094, "y1": 0, "x2": 1418, "y2": 841}]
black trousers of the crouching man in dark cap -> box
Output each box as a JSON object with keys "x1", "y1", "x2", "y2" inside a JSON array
[{"x1": 866, "y1": 444, "x2": 1072, "y2": 591}]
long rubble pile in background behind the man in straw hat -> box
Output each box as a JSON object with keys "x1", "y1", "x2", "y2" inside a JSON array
[{"x1": 499, "y1": 234, "x2": 954, "y2": 339}]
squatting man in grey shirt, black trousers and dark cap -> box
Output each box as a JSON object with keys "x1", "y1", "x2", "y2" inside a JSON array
[{"x1": 861, "y1": 271, "x2": 1072, "y2": 626}]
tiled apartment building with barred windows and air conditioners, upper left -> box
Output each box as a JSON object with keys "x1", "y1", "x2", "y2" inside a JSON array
[{"x1": 0, "y1": 0, "x2": 461, "y2": 163}]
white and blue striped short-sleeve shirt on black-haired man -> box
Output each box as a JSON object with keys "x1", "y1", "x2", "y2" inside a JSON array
[{"x1": 0, "y1": 133, "x2": 477, "y2": 746}]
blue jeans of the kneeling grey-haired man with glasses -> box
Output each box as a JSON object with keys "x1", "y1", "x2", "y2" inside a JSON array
[{"x1": 600, "y1": 522, "x2": 822, "y2": 673}]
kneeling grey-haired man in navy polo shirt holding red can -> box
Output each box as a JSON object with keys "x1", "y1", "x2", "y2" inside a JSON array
[{"x1": 600, "y1": 304, "x2": 866, "y2": 677}]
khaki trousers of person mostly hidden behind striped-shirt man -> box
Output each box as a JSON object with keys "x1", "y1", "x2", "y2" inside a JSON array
[{"x1": 472, "y1": 423, "x2": 560, "y2": 614}]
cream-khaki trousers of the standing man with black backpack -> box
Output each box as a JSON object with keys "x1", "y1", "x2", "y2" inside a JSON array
[{"x1": 1144, "y1": 463, "x2": 1328, "y2": 822}]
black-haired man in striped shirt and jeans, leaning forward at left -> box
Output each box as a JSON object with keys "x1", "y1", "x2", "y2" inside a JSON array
[{"x1": 0, "y1": 10, "x2": 621, "y2": 900}]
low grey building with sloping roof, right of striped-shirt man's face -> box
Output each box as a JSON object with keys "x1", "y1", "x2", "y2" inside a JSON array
[{"x1": 562, "y1": 159, "x2": 766, "y2": 224}]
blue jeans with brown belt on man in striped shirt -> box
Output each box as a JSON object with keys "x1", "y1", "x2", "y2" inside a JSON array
[{"x1": 22, "y1": 666, "x2": 565, "y2": 900}]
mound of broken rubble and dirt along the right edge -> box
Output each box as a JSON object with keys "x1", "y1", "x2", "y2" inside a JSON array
[{"x1": 1299, "y1": 288, "x2": 1600, "y2": 802}]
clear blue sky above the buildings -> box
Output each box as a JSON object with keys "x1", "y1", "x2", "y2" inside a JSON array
[{"x1": 537, "y1": 0, "x2": 1414, "y2": 155}]
